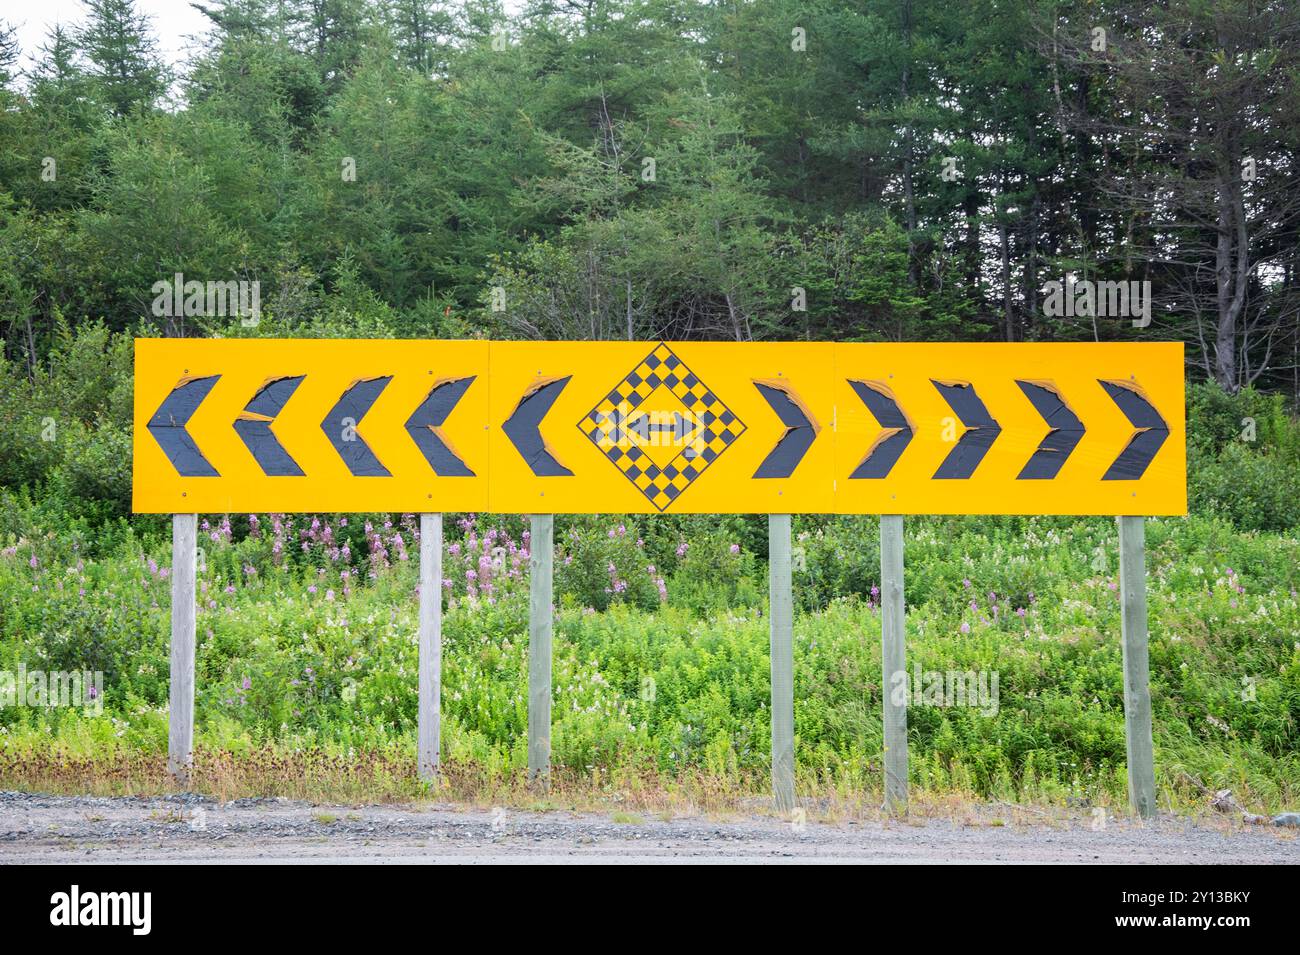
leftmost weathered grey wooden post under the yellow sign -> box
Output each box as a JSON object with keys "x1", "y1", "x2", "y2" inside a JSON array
[{"x1": 166, "y1": 515, "x2": 199, "y2": 785}]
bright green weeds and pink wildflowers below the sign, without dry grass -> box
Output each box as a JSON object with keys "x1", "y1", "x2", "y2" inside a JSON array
[{"x1": 0, "y1": 517, "x2": 1300, "y2": 808}]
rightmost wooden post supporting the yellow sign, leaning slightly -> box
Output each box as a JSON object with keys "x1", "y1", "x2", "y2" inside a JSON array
[{"x1": 1118, "y1": 516, "x2": 1156, "y2": 819}]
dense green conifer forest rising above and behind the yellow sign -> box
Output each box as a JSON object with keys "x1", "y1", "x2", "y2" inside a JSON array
[{"x1": 0, "y1": 0, "x2": 1300, "y2": 399}]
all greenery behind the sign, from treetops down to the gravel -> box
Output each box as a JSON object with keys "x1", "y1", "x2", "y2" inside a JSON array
[{"x1": 0, "y1": 0, "x2": 1300, "y2": 811}]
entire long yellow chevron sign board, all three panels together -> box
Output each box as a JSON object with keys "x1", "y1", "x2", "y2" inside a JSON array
[{"x1": 134, "y1": 339, "x2": 1187, "y2": 515}]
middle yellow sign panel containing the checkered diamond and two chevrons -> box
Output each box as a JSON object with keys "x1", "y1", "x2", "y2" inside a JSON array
[{"x1": 489, "y1": 342, "x2": 835, "y2": 513}]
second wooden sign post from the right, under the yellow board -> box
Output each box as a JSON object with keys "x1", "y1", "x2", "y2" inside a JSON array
[{"x1": 880, "y1": 515, "x2": 907, "y2": 812}]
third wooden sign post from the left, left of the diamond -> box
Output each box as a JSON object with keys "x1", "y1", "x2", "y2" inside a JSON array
[{"x1": 528, "y1": 515, "x2": 555, "y2": 786}]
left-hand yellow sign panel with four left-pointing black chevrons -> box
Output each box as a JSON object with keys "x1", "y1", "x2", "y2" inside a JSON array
[{"x1": 134, "y1": 339, "x2": 488, "y2": 513}]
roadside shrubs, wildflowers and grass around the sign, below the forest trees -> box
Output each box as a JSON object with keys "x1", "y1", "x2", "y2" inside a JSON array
[{"x1": 0, "y1": 329, "x2": 1300, "y2": 811}]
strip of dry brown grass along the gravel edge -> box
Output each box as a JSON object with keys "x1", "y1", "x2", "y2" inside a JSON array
[{"x1": 0, "y1": 747, "x2": 1232, "y2": 826}]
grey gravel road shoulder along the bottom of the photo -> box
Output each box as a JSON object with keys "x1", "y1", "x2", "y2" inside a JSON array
[{"x1": 0, "y1": 793, "x2": 1300, "y2": 864}]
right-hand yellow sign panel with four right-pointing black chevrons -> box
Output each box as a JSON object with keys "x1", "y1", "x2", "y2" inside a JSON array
[{"x1": 835, "y1": 342, "x2": 1187, "y2": 515}]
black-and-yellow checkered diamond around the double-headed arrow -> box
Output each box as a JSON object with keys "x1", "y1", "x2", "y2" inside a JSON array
[{"x1": 577, "y1": 342, "x2": 745, "y2": 511}]
